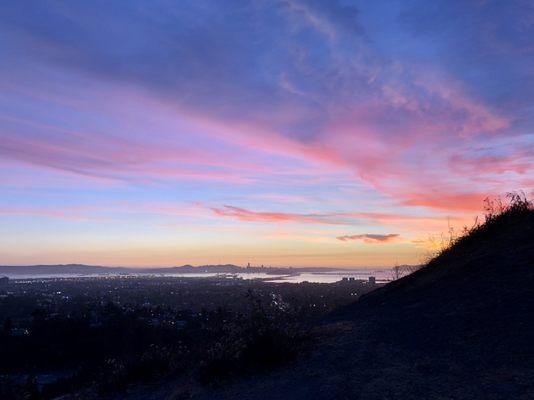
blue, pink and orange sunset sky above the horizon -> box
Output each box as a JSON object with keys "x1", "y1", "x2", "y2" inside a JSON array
[{"x1": 0, "y1": 0, "x2": 534, "y2": 267}]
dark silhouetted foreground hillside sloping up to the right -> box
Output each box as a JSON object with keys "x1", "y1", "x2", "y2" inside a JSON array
[{"x1": 124, "y1": 208, "x2": 534, "y2": 400}]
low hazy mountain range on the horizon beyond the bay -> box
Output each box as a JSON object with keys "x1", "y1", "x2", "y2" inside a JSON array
[{"x1": 0, "y1": 264, "x2": 386, "y2": 276}]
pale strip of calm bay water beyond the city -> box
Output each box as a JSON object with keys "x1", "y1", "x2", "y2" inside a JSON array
[{"x1": 2, "y1": 269, "x2": 391, "y2": 283}]
